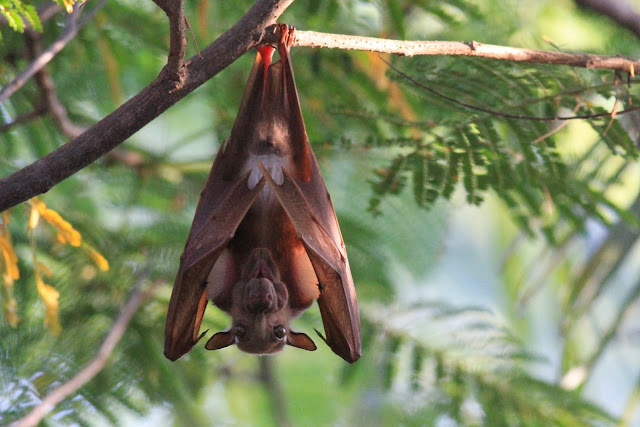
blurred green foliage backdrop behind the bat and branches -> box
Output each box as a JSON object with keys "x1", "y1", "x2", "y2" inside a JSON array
[{"x1": 0, "y1": 0, "x2": 640, "y2": 426}]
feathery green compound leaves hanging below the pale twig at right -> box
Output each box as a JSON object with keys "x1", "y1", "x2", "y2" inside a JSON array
[{"x1": 355, "y1": 58, "x2": 640, "y2": 243}]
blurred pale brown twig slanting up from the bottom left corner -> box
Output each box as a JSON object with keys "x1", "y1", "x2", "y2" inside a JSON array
[{"x1": 12, "y1": 283, "x2": 157, "y2": 427}]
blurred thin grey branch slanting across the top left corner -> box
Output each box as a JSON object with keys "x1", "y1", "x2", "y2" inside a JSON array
[{"x1": 0, "y1": 0, "x2": 106, "y2": 102}]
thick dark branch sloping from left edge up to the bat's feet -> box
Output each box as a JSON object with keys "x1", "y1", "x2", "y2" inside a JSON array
[{"x1": 0, "y1": 0, "x2": 293, "y2": 212}]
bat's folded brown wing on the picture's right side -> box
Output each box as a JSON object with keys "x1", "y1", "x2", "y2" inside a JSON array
[{"x1": 259, "y1": 162, "x2": 362, "y2": 363}]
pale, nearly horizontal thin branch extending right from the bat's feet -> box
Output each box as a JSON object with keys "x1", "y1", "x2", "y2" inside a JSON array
[{"x1": 293, "y1": 31, "x2": 640, "y2": 72}]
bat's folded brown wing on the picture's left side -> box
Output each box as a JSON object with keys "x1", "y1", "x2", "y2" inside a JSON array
[{"x1": 164, "y1": 171, "x2": 265, "y2": 360}]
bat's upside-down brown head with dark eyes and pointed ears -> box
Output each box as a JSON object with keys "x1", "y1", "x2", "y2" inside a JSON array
[{"x1": 205, "y1": 248, "x2": 316, "y2": 354}]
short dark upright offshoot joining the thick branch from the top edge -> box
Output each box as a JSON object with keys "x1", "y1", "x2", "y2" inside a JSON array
[{"x1": 153, "y1": 0, "x2": 187, "y2": 85}]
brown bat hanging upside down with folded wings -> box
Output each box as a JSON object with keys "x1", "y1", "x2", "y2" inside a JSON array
[{"x1": 164, "y1": 25, "x2": 361, "y2": 363}]
